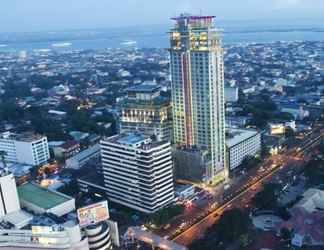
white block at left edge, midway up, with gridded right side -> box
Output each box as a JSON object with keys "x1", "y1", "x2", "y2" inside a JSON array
[{"x1": 0, "y1": 132, "x2": 50, "y2": 166}]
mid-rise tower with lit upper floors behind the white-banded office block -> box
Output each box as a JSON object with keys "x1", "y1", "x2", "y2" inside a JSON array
[{"x1": 120, "y1": 83, "x2": 172, "y2": 141}]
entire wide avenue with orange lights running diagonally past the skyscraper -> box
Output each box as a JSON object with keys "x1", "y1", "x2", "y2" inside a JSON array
[{"x1": 157, "y1": 125, "x2": 324, "y2": 246}]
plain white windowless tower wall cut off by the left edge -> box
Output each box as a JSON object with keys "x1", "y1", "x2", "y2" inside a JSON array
[{"x1": 0, "y1": 170, "x2": 20, "y2": 218}]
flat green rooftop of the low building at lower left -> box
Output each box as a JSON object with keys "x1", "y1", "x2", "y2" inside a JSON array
[{"x1": 17, "y1": 182, "x2": 71, "y2": 209}]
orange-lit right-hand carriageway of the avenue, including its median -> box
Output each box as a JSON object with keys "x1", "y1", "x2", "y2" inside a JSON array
[{"x1": 171, "y1": 128, "x2": 324, "y2": 246}]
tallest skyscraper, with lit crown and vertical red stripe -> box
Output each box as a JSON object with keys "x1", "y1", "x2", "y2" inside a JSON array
[{"x1": 170, "y1": 14, "x2": 225, "y2": 183}]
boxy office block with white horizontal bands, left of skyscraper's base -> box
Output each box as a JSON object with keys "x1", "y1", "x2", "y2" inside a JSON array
[{"x1": 101, "y1": 133, "x2": 175, "y2": 213}]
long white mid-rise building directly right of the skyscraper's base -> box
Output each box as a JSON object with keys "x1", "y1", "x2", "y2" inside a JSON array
[{"x1": 226, "y1": 129, "x2": 261, "y2": 171}]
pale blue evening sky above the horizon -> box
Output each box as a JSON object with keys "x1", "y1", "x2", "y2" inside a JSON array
[{"x1": 0, "y1": 0, "x2": 324, "y2": 32}]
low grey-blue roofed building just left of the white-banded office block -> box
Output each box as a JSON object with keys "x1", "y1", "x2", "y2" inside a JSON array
[{"x1": 65, "y1": 144, "x2": 100, "y2": 169}]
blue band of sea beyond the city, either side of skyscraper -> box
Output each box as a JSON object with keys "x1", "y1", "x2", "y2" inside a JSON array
[{"x1": 0, "y1": 21, "x2": 324, "y2": 52}]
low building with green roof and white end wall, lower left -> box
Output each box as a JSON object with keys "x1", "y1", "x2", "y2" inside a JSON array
[{"x1": 18, "y1": 183, "x2": 75, "y2": 216}]
